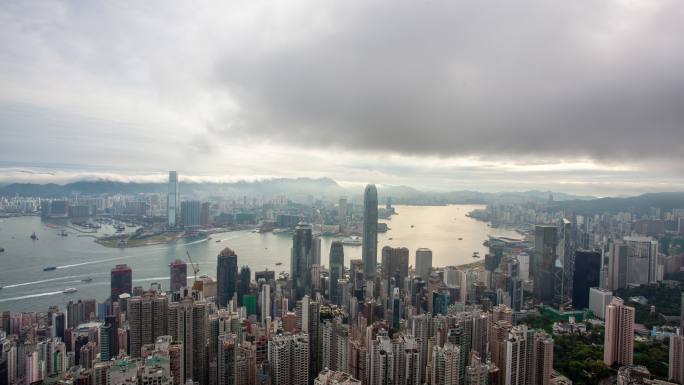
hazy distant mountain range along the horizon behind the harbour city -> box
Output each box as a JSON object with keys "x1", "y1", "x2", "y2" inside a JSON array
[{"x1": 0, "y1": 178, "x2": 592, "y2": 205}]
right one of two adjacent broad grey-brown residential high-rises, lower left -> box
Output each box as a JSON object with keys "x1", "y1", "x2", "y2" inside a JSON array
[{"x1": 168, "y1": 297, "x2": 209, "y2": 384}]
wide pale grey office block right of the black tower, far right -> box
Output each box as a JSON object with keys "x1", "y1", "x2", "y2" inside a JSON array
[{"x1": 624, "y1": 237, "x2": 663, "y2": 285}]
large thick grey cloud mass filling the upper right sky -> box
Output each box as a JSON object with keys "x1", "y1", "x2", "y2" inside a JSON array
[{"x1": 216, "y1": 0, "x2": 684, "y2": 160}]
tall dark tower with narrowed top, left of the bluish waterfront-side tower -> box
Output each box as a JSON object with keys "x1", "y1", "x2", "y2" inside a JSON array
[{"x1": 290, "y1": 223, "x2": 313, "y2": 301}]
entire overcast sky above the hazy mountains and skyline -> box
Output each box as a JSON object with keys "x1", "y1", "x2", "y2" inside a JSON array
[{"x1": 0, "y1": 0, "x2": 684, "y2": 195}]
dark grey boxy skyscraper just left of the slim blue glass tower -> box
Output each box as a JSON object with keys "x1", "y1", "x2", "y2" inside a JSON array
[{"x1": 532, "y1": 225, "x2": 558, "y2": 303}]
